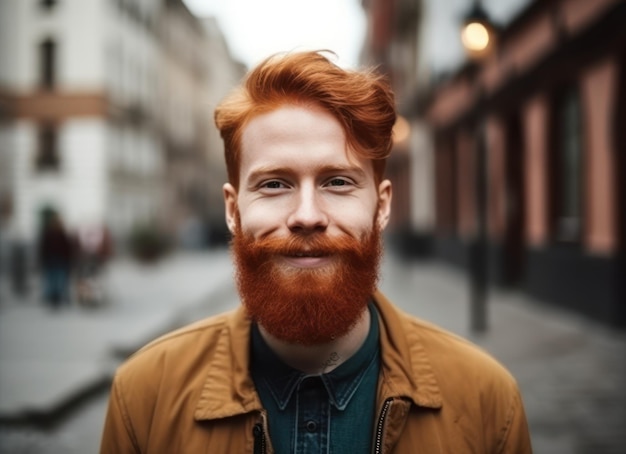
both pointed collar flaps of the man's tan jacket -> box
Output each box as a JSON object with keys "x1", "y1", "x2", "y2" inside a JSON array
[{"x1": 194, "y1": 291, "x2": 442, "y2": 420}]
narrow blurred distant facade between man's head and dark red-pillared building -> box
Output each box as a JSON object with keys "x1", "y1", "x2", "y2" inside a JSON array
[{"x1": 360, "y1": 0, "x2": 434, "y2": 257}]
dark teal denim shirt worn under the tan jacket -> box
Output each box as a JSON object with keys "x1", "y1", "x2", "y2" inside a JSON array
[{"x1": 251, "y1": 304, "x2": 380, "y2": 454}]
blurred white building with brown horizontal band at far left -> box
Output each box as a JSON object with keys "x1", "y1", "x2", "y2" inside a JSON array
[{"x1": 0, "y1": 0, "x2": 163, "y2": 245}]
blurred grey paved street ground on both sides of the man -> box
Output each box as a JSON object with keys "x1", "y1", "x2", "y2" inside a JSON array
[{"x1": 0, "y1": 249, "x2": 626, "y2": 454}]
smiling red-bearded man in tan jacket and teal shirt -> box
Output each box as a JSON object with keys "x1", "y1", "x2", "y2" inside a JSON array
[{"x1": 101, "y1": 52, "x2": 531, "y2": 454}]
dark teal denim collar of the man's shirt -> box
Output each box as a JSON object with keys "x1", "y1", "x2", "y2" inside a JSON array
[{"x1": 251, "y1": 304, "x2": 379, "y2": 410}]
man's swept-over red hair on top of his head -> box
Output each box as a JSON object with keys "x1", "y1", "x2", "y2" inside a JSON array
[{"x1": 215, "y1": 52, "x2": 396, "y2": 188}]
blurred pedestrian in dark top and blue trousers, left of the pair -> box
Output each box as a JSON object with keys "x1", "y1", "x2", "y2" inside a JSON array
[{"x1": 38, "y1": 210, "x2": 74, "y2": 308}]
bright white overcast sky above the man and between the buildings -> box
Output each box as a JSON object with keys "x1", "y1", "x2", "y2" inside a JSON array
[{"x1": 184, "y1": 0, "x2": 530, "y2": 72}]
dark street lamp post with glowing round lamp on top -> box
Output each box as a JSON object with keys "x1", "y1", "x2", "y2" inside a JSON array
[{"x1": 461, "y1": 0, "x2": 495, "y2": 334}]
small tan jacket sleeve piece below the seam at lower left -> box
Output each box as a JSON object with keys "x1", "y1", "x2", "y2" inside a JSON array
[{"x1": 100, "y1": 379, "x2": 141, "y2": 454}]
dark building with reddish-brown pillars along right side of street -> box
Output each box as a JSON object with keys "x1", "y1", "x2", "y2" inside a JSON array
[{"x1": 419, "y1": 0, "x2": 626, "y2": 326}]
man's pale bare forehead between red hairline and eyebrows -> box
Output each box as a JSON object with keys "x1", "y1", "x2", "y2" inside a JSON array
[{"x1": 240, "y1": 105, "x2": 372, "y2": 176}]
